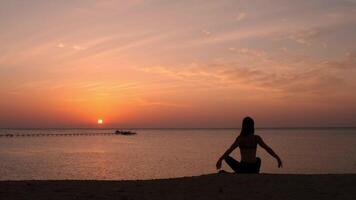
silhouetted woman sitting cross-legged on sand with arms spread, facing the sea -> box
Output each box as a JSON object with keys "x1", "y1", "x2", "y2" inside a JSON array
[{"x1": 216, "y1": 117, "x2": 282, "y2": 173}]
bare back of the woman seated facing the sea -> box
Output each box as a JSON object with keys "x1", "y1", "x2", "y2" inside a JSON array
[{"x1": 238, "y1": 135, "x2": 258, "y2": 163}]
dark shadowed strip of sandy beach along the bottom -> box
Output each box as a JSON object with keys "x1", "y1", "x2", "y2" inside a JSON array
[{"x1": 0, "y1": 174, "x2": 356, "y2": 200}]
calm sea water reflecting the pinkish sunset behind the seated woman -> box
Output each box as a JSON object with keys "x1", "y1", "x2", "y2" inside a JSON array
[{"x1": 0, "y1": 129, "x2": 356, "y2": 180}]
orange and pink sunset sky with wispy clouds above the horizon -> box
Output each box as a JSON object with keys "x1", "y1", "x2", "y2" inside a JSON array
[{"x1": 0, "y1": 0, "x2": 356, "y2": 128}]
